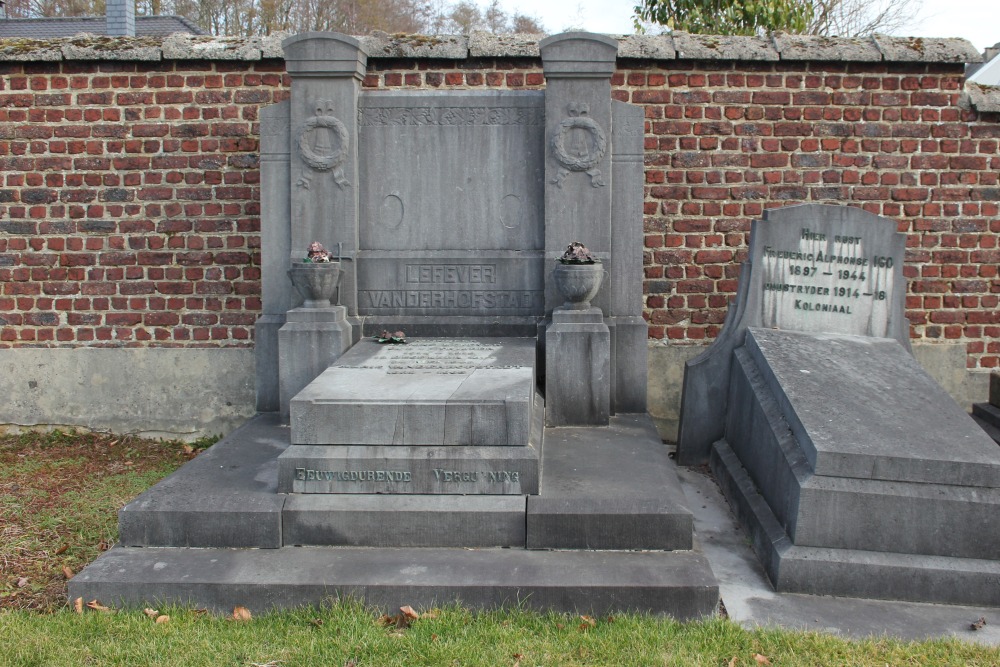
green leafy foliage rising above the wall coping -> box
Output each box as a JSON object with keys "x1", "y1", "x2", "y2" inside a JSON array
[{"x1": 635, "y1": 0, "x2": 813, "y2": 35}]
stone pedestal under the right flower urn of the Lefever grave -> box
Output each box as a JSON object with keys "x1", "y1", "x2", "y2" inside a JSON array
[{"x1": 545, "y1": 307, "x2": 611, "y2": 426}]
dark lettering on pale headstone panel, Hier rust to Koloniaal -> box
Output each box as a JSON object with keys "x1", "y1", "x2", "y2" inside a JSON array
[{"x1": 761, "y1": 225, "x2": 894, "y2": 333}]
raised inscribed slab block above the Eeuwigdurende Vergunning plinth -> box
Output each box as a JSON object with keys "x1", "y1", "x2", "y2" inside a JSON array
[{"x1": 291, "y1": 338, "x2": 535, "y2": 447}]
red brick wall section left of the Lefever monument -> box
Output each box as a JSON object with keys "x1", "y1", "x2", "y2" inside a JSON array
[{"x1": 0, "y1": 61, "x2": 287, "y2": 347}]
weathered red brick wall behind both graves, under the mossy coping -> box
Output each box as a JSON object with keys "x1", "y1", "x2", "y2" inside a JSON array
[{"x1": 0, "y1": 48, "x2": 1000, "y2": 368}]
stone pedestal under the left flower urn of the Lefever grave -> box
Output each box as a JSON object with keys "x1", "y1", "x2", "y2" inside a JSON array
[{"x1": 278, "y1": 306, "x2": 351, "y2": 422}]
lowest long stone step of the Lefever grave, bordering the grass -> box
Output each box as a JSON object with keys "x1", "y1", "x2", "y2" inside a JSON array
[{"x1": 69, "y1": 547, "x2": 719, "y2": 620}]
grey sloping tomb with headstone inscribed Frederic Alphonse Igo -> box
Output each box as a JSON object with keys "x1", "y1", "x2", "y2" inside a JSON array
[{"x1": 679, "y1": 205, "x2": 1000, "y2": 605}]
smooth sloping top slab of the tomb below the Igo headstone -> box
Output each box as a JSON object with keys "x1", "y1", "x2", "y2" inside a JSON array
[{"x1": 737, "y1": 329, "x2": 1000, "y2": 488}]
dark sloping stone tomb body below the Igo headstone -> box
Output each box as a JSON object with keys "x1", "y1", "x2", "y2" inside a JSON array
[{"x1": 710, "y1": 328, "x2": 1000, "y2": 605}]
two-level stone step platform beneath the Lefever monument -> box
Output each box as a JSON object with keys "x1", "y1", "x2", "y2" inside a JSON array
[{"x1": 76, "y1": 414, "x2": 718, "y2": 619}]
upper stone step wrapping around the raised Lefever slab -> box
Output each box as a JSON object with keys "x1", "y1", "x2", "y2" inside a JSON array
[{"x1": 119, "y1": 415, "x2": 692, "y2": 550}]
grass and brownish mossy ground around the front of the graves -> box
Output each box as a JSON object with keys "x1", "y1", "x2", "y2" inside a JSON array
[{"x1": 0, "y1": 432, "x2": 1000, "y2": 667}]
